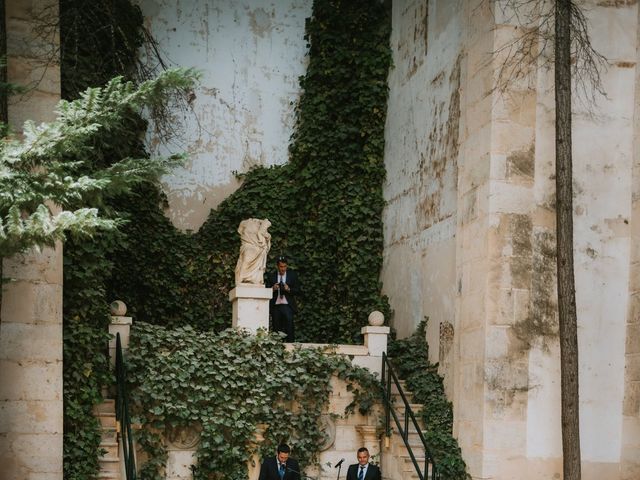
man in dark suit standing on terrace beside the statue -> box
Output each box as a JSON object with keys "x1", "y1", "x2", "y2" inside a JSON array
[{"x1": 265, "y1": 257, "x2": 300, "y2": 342}]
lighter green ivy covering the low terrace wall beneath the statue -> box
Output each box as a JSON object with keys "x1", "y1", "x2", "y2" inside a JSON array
[{"x1": 128, "y1": 322, "x2": 381, "y2": 480}]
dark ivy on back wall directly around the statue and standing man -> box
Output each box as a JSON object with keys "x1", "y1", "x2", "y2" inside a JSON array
[{"x1": 109, "y1": 0, "x2": 391, "y2": 343}]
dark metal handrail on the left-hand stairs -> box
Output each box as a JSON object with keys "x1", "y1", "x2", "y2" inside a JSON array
[{"x1": 116, "y1": 333, "x2": 136, "y2": 480}]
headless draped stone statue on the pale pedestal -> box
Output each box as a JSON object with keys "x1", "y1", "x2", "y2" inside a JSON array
[{"x1": 236, "y1": 218, "x2": 271, "y2": 285}]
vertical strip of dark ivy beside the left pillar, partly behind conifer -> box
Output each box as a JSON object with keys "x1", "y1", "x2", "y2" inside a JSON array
[{"x1": 57, "y1": 0, "x2": 162, "y2": 480}]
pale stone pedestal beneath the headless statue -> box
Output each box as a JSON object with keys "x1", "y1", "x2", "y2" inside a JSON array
[{"x1": 229, "y1": 283, "x2": 273, "y2": 333}]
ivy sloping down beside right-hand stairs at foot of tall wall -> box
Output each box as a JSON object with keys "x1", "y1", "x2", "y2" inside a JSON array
[{"x1": 388, "y1": 320, "x2": 470, "y2": 480}]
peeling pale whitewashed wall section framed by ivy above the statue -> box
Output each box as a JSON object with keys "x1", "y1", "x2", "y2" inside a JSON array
[{"x1": 138, "y1": 0, "x2": 312, "y2": 230}]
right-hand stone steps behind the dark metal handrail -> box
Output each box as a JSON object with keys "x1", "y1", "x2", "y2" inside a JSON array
[{"x1": 383, "y1": 381, "x2": 432, "y2": 480}]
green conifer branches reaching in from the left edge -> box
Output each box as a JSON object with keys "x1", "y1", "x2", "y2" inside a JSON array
[{"x1": 0, "y1": 70, "x2": 195, "y2": 257}]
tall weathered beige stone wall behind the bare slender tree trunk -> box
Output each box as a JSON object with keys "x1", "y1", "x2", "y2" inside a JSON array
[{"x1": 382, "y1": 0, "x2": 640, "y2": 479}]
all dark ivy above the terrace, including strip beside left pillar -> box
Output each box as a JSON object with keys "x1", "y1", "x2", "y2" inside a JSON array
[{"x1": 60, "y1": 0, "x2": 390, "y2": 479}]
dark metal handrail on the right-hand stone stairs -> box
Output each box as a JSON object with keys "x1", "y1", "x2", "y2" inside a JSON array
[{"x1": 382, "y1": 352, "x2": 440, "y2": 480}]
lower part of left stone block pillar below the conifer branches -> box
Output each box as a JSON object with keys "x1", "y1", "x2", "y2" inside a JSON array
[{"x1": 0, "y1": 245, "x2": 63, "y2": 480}]
